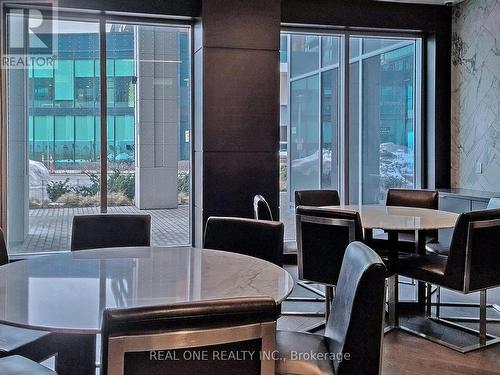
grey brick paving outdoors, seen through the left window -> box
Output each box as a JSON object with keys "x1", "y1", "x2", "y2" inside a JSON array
[{"x1": 10, "y1": 205, "x2": 190, "y2": 253}]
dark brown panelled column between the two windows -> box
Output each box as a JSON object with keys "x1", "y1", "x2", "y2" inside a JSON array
[{"x1": 193, "y1": 0, "x2": 281, "y2": 246}]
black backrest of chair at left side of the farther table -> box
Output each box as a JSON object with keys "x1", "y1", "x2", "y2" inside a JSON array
[{"x1": 295, "y1": 206, "x2": 363, "y2": 285}]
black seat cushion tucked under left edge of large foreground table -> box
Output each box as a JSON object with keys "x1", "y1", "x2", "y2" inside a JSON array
[{"x1": 0, "y1": 324, "x2": 50, "y2": 356}]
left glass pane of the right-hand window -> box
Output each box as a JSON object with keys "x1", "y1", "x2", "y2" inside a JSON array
[{"x1": 289, "y1": 34, "x2": 340, "y2": 200}]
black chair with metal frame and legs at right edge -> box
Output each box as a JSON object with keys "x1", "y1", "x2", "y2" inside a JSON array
[{"x1": 393, "y1": 209, "x2": 500, "y2": 352}]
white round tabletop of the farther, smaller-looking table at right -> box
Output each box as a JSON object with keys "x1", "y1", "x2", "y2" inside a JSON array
[{"x1": 323, "y1": 205, "x2": 458, "y2": 231}]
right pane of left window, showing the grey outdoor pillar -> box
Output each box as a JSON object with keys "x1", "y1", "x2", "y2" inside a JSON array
[{"x1": 106, "y1": 22, "x2": 191, "y2": 245}]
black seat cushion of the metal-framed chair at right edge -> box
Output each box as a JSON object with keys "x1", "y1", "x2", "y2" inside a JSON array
[{"x1": 392, "y1": 254, "x2": 448, "y2": 285}]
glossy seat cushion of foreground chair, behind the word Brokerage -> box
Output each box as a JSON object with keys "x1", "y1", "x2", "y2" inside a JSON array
[{"x1": 276, "y1": 331, "x2": 334, "y2": 375}]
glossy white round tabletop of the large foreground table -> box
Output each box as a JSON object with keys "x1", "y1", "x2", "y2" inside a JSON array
[{"x1": 0, "y1": 247, "x2": 293, "y2": 333}]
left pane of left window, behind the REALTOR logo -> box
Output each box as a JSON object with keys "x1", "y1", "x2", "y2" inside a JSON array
[{"x1": 7, "y1": 11, "x2": 100, "y2": 253}]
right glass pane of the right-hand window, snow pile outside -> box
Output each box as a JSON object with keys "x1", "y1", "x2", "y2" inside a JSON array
[{"x1": 349, "y1": 37, "x2": 418, "y2": 204}]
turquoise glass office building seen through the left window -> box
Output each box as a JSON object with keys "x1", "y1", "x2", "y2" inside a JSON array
[{"x1": 28, "y1": 26, "x2": 190, "y2": 170}]
